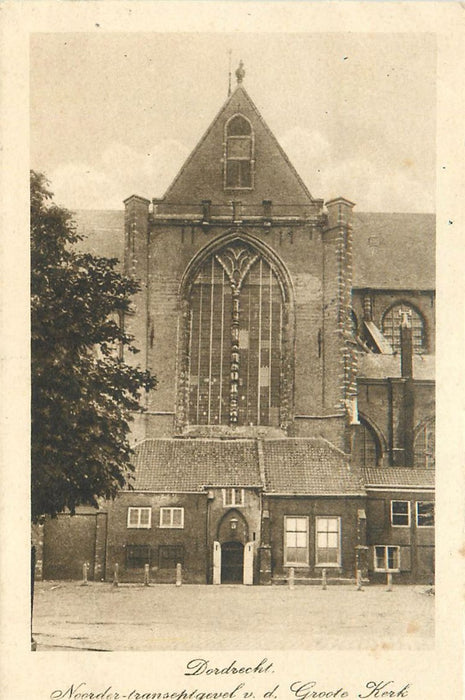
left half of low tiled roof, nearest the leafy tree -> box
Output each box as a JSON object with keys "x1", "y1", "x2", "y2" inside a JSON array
[{"x1": 132, "y1": 438, "x2": 261, "y2": 492}]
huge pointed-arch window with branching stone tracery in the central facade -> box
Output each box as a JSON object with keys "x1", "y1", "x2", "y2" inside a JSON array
[{"x1": 187, "y1": 241, "x2": 283, "y2": 426}]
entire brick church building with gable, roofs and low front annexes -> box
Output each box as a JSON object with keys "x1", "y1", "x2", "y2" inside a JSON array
[{"x1": 33, "y1": 69, "x2": 435, "y2": 584}]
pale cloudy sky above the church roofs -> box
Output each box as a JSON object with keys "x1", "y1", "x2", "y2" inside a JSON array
[{"x1": 30, "y1": 33, "x2": 436, "y2": 212}]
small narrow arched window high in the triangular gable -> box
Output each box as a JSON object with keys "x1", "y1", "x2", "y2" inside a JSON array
[{"x1": 224, "y1": 114, "x2": 254, "y2": 190}]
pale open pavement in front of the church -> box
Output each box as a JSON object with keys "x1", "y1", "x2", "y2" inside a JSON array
[{"x1": 33, "y1": 581, "x2": 434, "y2": 651}]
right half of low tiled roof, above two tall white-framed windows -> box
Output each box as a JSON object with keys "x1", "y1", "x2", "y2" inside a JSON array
[{"x1": 263, "y1": 438, "x2": 364, "y2": 496}]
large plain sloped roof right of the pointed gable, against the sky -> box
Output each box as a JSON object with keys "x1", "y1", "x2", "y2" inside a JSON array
[{"x1": 353, "y1": 212, "x2": 436, "y2": 290}]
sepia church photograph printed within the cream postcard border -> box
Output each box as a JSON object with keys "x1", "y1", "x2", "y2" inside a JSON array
[{"x1": 29, "y1": 32, "x2": 437, "y2": 652}]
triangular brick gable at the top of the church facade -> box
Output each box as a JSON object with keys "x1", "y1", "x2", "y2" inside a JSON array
[{"x1": 158, "y1": 85, "x2": 313, "y2": 213}]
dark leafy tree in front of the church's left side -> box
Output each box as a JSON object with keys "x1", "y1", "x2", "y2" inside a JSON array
[{"x1": 31, "y1": 172, "x2": 156, "y2": 521}]
